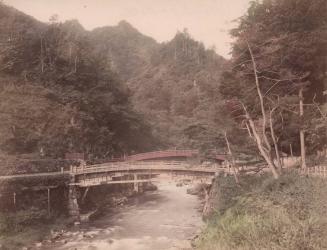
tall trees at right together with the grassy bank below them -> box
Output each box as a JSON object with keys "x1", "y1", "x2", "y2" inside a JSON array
[{"x1": 197, "y1": 0, "x2": 327, "y2": 250}]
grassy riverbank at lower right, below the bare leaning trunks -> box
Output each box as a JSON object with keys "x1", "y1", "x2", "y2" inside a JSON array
[{"x1": 195, "y1": 172, "x2": 327, "y2": 250}]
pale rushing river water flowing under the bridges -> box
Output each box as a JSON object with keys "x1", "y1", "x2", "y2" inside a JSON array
[{"x1": 46, "y1": 177, "x2": 203, "y2": 250}]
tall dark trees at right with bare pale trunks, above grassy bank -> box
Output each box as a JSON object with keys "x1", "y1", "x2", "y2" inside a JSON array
[{"x1": 220, "y1": 0, "x2": 327, "y2": 178}]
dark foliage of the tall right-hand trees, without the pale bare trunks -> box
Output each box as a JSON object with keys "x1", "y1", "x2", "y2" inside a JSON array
[{"x1": 220, "y1": 0, "x2": 327, "y2": 156}]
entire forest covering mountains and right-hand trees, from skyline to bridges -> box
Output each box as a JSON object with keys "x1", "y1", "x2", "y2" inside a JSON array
[{"x1": 0, "y1": 1, "x2": 327, "y2": 169}]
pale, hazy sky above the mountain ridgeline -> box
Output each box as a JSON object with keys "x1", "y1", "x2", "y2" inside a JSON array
[{"x1": 3, "y1": 0, "x2": 250, "y2": 57}]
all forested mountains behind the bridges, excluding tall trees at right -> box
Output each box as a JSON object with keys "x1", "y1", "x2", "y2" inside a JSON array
[{"x1": 0, "y1": 4, "x2": 225, "y2": 160}]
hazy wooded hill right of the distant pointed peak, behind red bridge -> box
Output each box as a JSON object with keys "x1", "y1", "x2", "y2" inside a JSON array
[{"x1": 127, "y1": 31, "x2": 225, "y2": 148}]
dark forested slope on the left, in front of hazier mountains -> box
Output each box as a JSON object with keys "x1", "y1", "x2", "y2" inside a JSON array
[{"x1": 0, "y1": 2, "x2": 159, "y2": 157}]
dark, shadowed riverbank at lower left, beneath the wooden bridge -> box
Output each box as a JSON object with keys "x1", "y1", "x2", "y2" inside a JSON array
[{"x1": 0, "y1": 180, "x2": 149, "y2": 250}]
